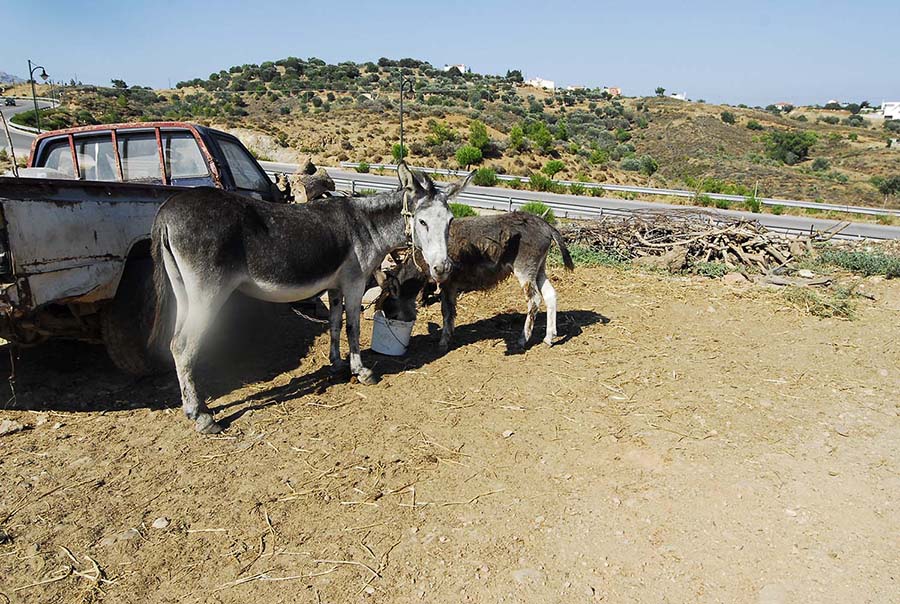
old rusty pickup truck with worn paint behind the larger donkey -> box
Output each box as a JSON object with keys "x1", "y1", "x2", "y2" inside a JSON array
[{"x1": 0, "y1": 122, "x2": 283, "y2": 375}]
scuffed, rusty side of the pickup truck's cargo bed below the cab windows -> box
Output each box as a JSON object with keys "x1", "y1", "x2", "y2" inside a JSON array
[{"x1": 0, "y1": 177, "x2": 187, "y2": 309}]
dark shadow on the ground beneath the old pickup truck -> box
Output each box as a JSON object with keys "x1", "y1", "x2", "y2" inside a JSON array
[{"x1": 0, "y1": 300, "x2": 327, "y2": 412}]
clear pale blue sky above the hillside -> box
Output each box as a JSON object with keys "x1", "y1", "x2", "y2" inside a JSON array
[{"x1": 0, "y1": 0, "x2": 900, "y2": 105}]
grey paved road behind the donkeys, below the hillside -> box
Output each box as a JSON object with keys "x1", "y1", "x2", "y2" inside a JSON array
[{"x1": 300, "y1": 162, "x2": 900, "y2": 239}]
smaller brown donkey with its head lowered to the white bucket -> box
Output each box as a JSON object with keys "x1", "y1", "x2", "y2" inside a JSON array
[{"x1": 375, "y1": 212, "x2": 575, "y2": 352}]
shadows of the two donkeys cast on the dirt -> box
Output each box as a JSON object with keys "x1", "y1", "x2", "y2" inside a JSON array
[{"x1": 232, "y1": 310, "x2": 610, "y2": 418}]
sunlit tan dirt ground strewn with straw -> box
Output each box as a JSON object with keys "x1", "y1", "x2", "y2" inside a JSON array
[{"x1": 0, "y1": 268, "x2": 900, "y2": 604}]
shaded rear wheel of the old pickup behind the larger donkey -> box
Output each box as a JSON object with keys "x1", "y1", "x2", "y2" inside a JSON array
[{"x1": 100, "y1": 259, "x2": 172, "y2": 376}]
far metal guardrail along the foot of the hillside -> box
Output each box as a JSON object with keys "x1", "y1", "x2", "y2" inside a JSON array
[{"x1": 341, "y1": 162, "x2": 900, "y2": 216}]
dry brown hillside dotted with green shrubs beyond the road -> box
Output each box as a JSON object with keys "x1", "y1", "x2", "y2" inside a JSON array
[{"x1": 8, "y1": 57, "x2": 900, "y2": 206}]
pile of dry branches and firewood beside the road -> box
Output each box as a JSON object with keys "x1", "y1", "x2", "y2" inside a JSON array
[{"x1": 562, "y1": 210, "x2": 816, "y2": 272}]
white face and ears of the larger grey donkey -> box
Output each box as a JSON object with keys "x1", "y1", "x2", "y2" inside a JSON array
[{"x1": 397, "y1": 163, "x2": 474, "y2": 283}]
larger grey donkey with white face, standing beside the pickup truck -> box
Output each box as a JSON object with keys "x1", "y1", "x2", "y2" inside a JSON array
[{"x1": 151, "y1": 163, "x2": 472, "y2": 434}]
